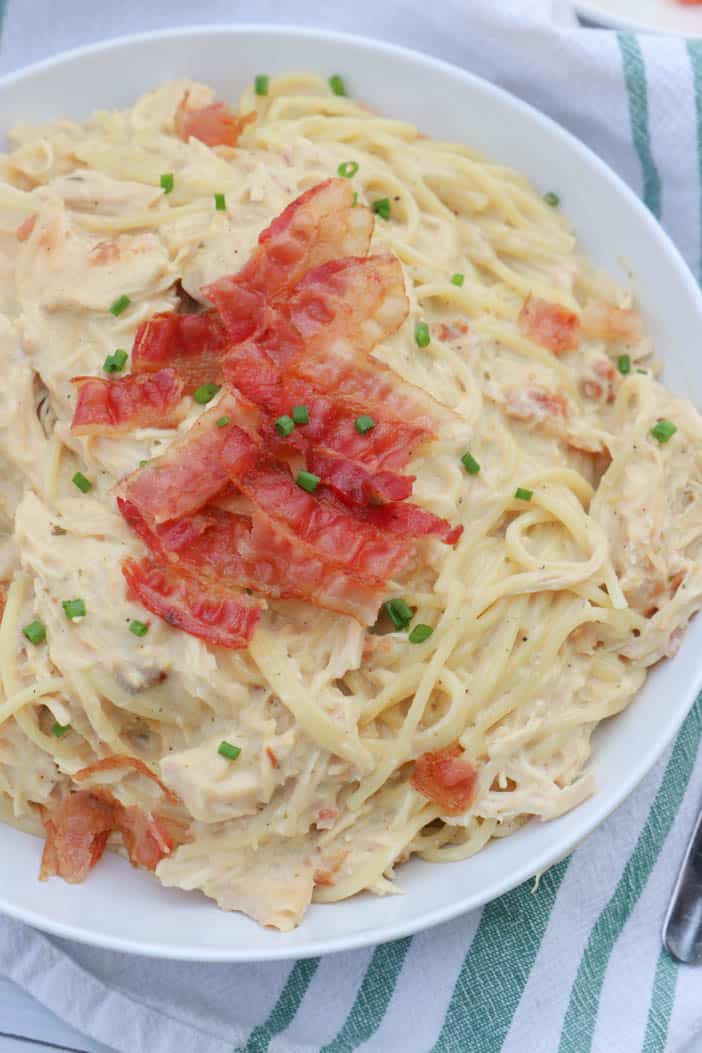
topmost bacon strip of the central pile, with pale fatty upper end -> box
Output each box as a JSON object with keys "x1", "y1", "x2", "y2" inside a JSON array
[{"x1": 202, "y1": 179, "x2": 373, "y2": 332}]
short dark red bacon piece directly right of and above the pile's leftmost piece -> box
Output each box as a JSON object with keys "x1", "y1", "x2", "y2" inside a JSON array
[{"x1": 132, "y1": 311, "x2": 230, "y2": 395}]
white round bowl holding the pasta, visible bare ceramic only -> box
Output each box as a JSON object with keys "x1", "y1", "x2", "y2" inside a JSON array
[{"x1": 0, "y1": 25, "x2": 702, "y2": 961}]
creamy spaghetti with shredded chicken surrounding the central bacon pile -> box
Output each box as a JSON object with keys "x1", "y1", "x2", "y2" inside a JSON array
[{"x1": 0, "y1": 75, "x2": 702, "y2": 930}]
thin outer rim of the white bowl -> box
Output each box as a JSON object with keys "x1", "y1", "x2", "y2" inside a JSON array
[{"x1": 0, "y1": 21, "x2": 702, "y2": 962}]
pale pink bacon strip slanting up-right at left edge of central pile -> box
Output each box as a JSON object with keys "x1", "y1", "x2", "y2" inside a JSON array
[{"x1": 115, "y1": 394, "x2": 256, "y2": 523}]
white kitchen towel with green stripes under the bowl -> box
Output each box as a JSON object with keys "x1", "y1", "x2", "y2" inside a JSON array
[{"x1": 0, "y1": 0, "x2": 702, "y2": 1053}]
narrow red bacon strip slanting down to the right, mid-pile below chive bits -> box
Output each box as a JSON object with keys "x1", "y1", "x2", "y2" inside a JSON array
[{"x1": 216, "y1": 426, "x2": 412, "y2": 583}]
